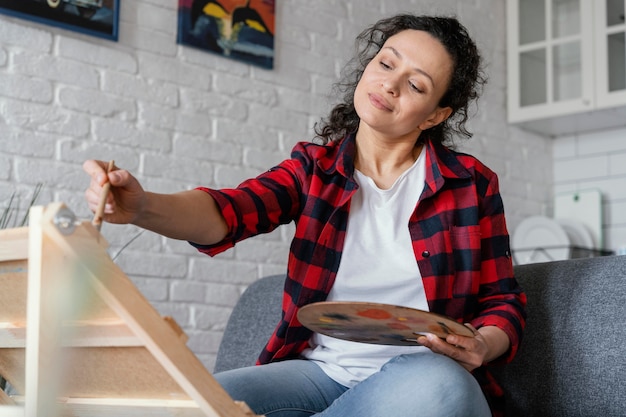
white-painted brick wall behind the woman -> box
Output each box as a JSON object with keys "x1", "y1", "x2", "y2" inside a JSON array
[{"x1": 0, "y1": 0, "x2": 548, "y2": 369}]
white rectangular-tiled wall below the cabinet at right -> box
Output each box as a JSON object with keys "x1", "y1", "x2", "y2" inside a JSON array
[{"x1": 553, "y1": 129, "x2": 626, "y2": 251}]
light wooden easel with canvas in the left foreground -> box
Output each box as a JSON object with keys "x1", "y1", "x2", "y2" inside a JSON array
[{"x1": 0, "y1": 203, "x2": 254, "y2": 417}]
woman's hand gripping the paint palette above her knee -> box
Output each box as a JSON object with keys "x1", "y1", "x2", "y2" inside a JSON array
[{"x1": 417, "y1": 324, "x2": 509, "y2": 372}]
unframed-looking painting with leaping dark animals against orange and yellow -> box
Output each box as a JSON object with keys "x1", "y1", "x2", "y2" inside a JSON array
[{"x1": 178, "y1": 0, "x2": 275, "y2": 69}]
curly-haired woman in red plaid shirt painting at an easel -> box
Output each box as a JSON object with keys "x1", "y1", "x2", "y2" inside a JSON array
[{"x1": 84, "y1": 15, "x2": 526, "y2": 417}]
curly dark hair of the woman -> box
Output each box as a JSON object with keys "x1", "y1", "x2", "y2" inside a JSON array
[{"x1": 315, "y1": 14, "x2": 486, "y2": 144}]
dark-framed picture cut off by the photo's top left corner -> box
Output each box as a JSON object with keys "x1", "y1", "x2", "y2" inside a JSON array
[{"x1": 0, "y1": 0, "x2": 120, "y2": 41}]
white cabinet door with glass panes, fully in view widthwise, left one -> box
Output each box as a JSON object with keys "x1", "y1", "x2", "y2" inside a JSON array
[{"x1": 507, "y1": 0, "x2": 592, "y2": 122}]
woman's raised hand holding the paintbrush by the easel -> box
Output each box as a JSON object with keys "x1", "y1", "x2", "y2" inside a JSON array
[{"x1": 83, "y1": 160, "x2": 146, "y2": 224}]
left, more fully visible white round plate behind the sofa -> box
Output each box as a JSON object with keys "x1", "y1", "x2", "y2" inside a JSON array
[{"x1": 511, "y1": 216, "x2": 571, "y2": 264}]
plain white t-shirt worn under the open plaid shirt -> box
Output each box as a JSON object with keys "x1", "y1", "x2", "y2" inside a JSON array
[{"x1": 303, "y1": 152, "x2": 430, "y2": 387}]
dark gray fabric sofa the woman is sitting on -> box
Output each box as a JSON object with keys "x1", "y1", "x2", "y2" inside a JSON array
[{"x1": 215, "y1": 256, "x2": 626, "y2": 417}]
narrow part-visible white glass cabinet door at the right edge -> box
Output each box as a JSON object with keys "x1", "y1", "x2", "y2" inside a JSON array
[{"x1": 595, "y1": 0, "x2": 626, "y2": 108}]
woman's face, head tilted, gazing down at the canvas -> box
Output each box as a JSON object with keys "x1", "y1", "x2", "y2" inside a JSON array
[{"x1": 354, "y1": 30, "x2": 453, "y2": 141}]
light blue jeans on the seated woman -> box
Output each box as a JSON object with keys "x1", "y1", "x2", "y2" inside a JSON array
[{"x1": 215, "y1": 352, "x2": 491, "y2": 417}]
